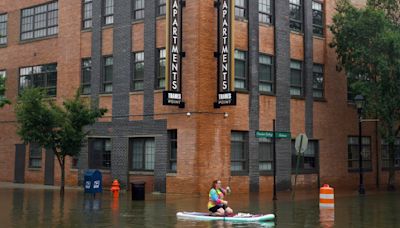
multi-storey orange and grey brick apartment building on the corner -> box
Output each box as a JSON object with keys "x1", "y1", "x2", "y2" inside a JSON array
[{"x1": 0, "y1": 0, "x2": 400, "y2": 193}]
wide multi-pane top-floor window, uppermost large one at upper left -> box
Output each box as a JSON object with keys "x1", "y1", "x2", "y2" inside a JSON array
[{"x1": 21, "y1": 2, "x2": 58, "y2": 40}]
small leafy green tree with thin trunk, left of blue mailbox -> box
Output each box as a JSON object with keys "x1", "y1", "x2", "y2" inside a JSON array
[{"x1": 15, "y1": 88, "x2": 107, "y2": 196}]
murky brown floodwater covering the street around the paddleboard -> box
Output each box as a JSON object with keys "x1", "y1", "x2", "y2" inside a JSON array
[{"x1": 0, "y1": 183, "x2": 400, "y2": 228}]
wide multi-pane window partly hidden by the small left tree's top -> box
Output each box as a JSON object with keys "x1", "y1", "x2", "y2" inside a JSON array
[{"x1": 19, "y1": 63, "x2": 57, "y2": 96}]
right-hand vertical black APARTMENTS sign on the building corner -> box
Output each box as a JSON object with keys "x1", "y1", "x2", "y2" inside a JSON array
[{"x1": 214, "y1": 0, "x2": 236, "y2": 108}]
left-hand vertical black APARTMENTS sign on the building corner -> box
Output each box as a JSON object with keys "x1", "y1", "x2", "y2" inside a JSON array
[{"x1": 163, "y1": 0, "x2": 185, "y2": 108}]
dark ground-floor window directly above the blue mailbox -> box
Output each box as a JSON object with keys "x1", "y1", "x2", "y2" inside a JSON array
[{"x1": 89, "y1": 138, "x2": 112, "y2": 169}]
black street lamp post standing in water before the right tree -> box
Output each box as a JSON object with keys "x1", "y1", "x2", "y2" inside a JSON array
[{"x1": 354, "y1": 95, "x2": 365, "y2": 195}]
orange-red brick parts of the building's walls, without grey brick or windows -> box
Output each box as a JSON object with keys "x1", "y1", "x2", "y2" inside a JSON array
[{"x1": 0, "y1": 0, "x2": 399, "y2": 194}]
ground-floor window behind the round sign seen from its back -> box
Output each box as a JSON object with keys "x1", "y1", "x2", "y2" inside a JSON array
[{"x1": 292, "y1": 140, "x2": 319, "y2": 172}]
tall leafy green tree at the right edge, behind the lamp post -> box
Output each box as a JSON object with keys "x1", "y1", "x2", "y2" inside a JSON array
[{"x1": 330, "y1": 0, "x2": 400, "y2": 190}]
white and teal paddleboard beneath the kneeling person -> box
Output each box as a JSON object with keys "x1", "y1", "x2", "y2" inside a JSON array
[{"x1": 176, "y1": 212, "x2": 275, "y2": 222}]
